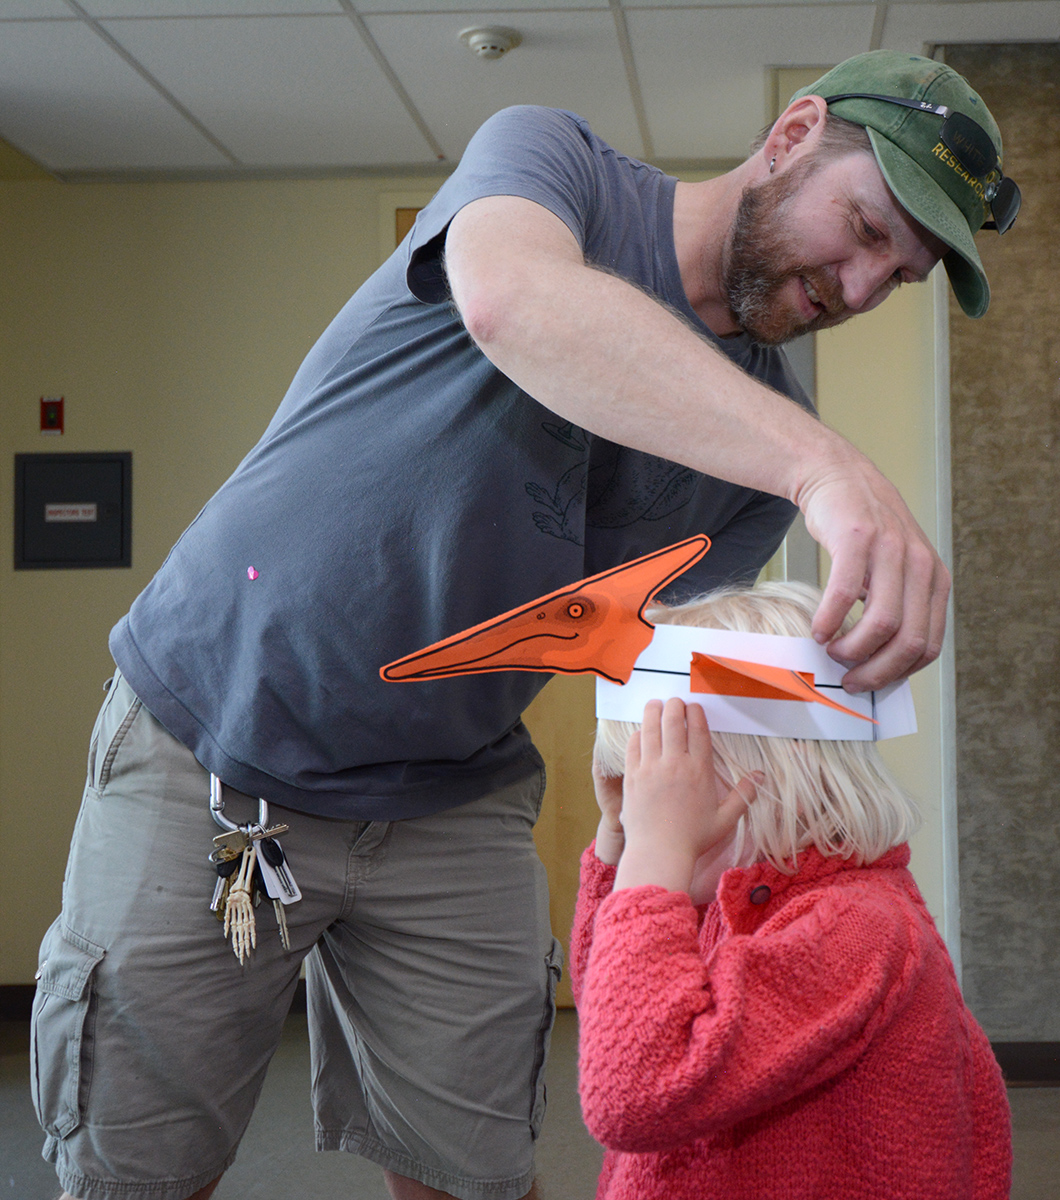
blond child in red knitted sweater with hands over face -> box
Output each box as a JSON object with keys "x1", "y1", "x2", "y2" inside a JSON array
[{"x1": 571, "y1": 584, "x2": 1011, "y2": 1200}]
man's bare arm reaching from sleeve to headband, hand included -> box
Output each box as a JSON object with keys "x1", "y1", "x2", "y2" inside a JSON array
[{"x1": 445, "y1": 196, "x2": 950, "y2": 691}]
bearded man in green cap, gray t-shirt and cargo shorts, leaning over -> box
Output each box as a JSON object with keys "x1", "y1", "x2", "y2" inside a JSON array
[{"x1": 35, "y1": 52, "x2": 1018, "y2": 1200}]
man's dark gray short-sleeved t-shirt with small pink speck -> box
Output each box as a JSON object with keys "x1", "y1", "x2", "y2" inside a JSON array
[{"x1": 110, "y1": 107, "x2": 810, "y2": 820}]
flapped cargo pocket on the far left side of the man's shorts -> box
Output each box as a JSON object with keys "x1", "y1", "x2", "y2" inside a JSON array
[{"x1": 30, "y1": 920, "x2": 106, "y2": 1138}]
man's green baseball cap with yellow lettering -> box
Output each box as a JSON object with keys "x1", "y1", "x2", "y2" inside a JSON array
[{"x1": 791, "y1": 50, "x2": 1001, "y2": 317}]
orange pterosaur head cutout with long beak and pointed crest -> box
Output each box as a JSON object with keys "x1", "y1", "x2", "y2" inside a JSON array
[{"x1": 379, "y1": 534, "x2": 711, "y2": 683}]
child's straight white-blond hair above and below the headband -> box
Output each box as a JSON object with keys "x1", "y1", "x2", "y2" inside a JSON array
[{"x1": 595, "y1": 583, "x2": 921, "y2": 874}]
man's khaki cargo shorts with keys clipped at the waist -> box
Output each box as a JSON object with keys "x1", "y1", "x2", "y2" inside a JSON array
[{"x1": 32, "y1": 674, "x2": 559, "y2": 1200}]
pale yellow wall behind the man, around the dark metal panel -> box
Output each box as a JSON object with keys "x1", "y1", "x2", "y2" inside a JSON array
[{"x1": 0, "y1": 171, "x2": 941, "y2": 984}]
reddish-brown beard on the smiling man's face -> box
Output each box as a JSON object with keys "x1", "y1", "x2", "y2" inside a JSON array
[{"x1": 721, "y1": 161, "x2": 852, "y2": 346}]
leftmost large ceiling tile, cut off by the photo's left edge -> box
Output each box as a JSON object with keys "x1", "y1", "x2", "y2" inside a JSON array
[{"x1": 0, "y1": 22, "x2": 227, "y2": 172}]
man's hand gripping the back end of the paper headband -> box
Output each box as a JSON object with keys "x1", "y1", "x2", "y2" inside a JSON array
[{"x1": 800, "y1": 457, "x2": 950, "y2": 692}]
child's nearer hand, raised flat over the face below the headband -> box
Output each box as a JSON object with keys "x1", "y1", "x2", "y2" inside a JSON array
[{"x1": 615, "y1": 698, "x2": 756, "y2": 892}]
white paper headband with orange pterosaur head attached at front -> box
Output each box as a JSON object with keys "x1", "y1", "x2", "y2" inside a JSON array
[{"x1": 379, "y1": 535, "x2": 916, "y2": 742}]
